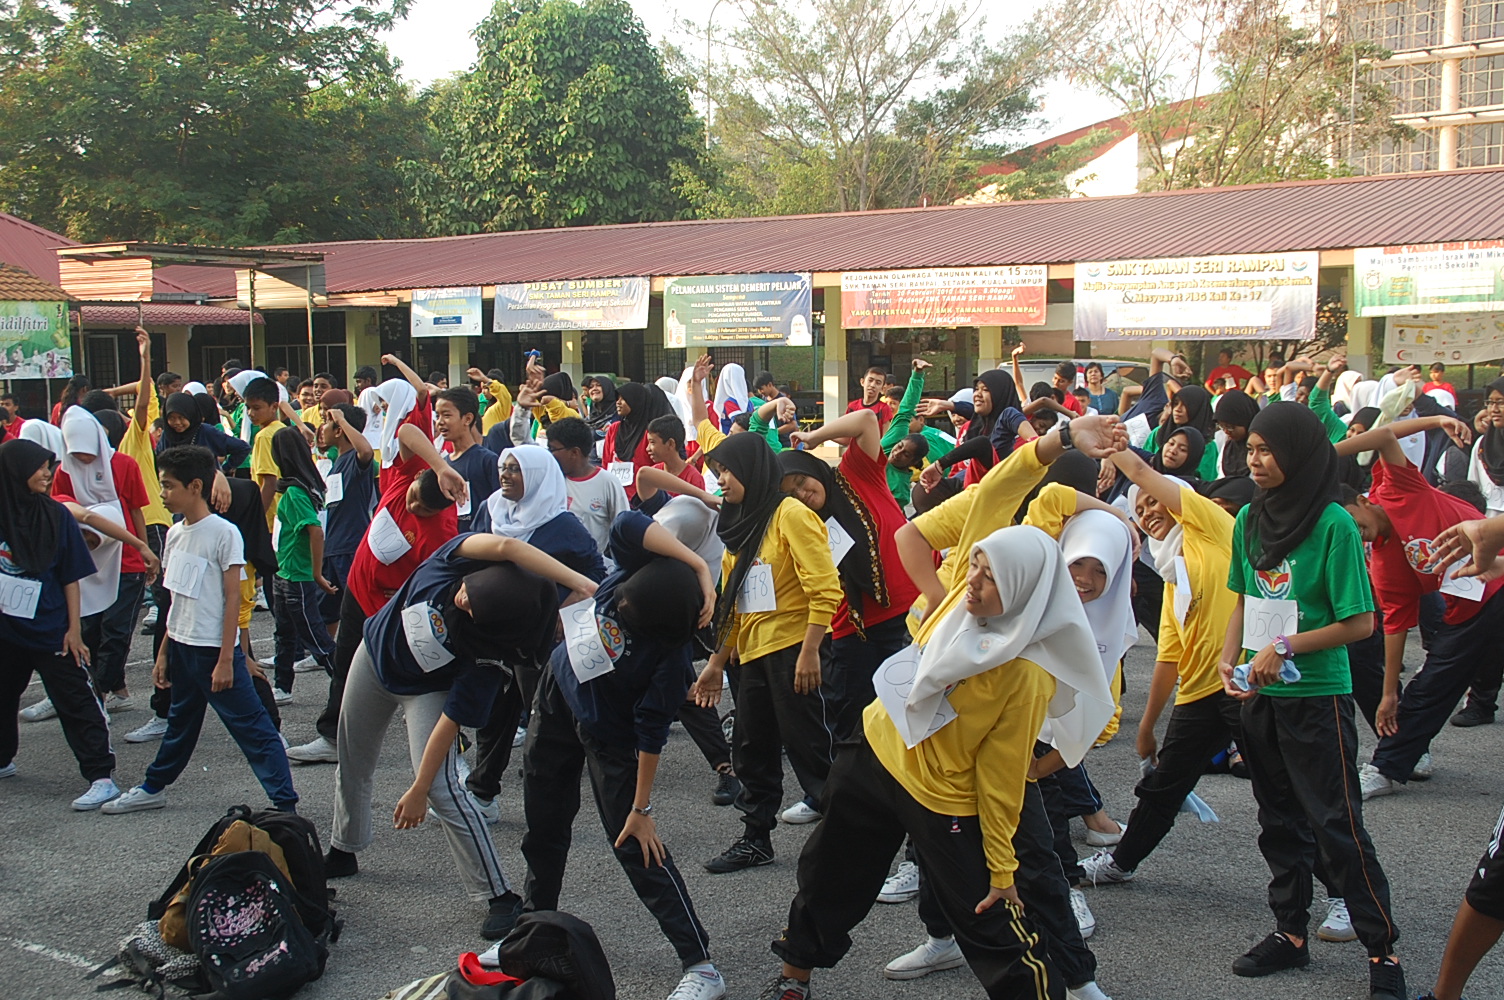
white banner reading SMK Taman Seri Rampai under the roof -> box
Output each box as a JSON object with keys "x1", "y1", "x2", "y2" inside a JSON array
[{"x1": 1075, "y1": 253, "x2": 1321, "y2": 340}]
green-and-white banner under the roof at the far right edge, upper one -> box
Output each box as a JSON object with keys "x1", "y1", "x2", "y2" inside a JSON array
[{"x1": 1352, "y1": 239, "x2": 1504, "y2": 316}]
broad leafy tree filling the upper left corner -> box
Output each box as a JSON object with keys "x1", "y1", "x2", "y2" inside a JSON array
[{"x1": 0, "y1": 0, "x2": 424, "y2": 244}]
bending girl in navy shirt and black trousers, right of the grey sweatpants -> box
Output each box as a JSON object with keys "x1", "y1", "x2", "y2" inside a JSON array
[{"x1": 522, "y1": 511, "x2": 726, "y2": 1000}]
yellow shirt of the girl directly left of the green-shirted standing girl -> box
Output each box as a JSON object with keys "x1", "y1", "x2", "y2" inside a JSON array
[{"x1": 1157, "y1": 486, "x2": 1238, "y2": 705}]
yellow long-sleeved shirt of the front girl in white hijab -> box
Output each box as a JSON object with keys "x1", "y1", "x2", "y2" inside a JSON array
[{"x1": 862, "y1": 659, "x2": 1054, "y2": 889}]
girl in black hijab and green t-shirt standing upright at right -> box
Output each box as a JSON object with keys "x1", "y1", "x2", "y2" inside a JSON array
[{"x1": 1215, "y1": 402, "x2": 1405, "y2": 1000}]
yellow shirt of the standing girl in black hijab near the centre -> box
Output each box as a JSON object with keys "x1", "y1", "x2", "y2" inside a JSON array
[{"x1": 720, "y1": 496, "x2": 842, "y2": 663}]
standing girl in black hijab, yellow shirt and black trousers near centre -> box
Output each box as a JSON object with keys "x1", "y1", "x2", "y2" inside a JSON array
[{"x1": 694, "y1": 433, "x2": 842, "y2": 875}]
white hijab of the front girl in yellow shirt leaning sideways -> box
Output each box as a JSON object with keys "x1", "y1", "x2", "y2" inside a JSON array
[{"x1": 904, "y1": 525, "x2": 1116, "y2": 767}]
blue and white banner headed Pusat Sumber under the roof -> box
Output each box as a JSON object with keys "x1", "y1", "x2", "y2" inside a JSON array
[{"x1": 490, "y1": 278, "x2": 651, "y2": 334}]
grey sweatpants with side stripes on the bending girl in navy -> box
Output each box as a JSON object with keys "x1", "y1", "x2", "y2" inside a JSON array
[{"x1": 329, "y1": 642, "x2": 511, "y2": 902}]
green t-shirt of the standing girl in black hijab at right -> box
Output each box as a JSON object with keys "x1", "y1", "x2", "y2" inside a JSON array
[{"x1": 1227, "y1": 504, "x2": 1373, "y2": 698}]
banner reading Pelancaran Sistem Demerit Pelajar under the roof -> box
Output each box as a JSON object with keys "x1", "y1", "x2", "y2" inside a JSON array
[{"x1": 663, "y1": 274, "x2": 814, "y2": 347}]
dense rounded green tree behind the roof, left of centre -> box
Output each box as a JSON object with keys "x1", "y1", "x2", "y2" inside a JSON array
[{"x1": 403, "y1": 0, "x2": 710, "y2": 235}]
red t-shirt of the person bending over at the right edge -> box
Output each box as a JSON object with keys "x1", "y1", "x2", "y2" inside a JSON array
[{"x1": 1369, "y1": 459, "x2": 1504, "y2": 635}]
